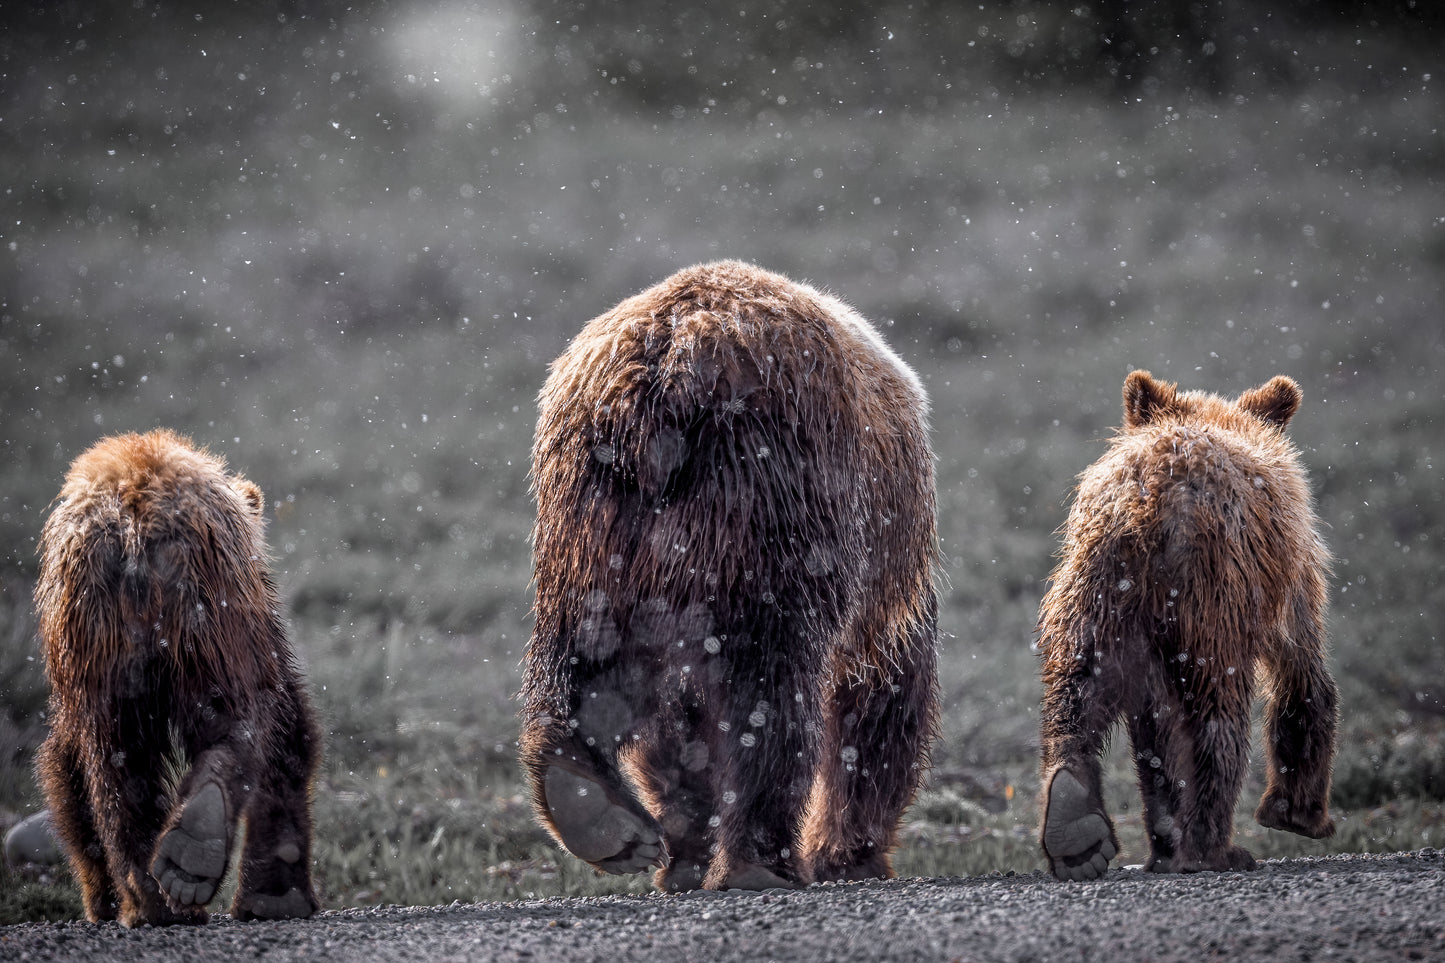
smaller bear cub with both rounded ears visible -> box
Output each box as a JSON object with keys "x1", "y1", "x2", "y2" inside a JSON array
[{"x1": 1039, "y1": 372, "x2": 1338, "y2": 879}]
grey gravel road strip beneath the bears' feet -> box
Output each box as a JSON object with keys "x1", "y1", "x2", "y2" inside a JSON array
[{"x1": 0, "y1": 849, "x2": 1445, "y2": 963}]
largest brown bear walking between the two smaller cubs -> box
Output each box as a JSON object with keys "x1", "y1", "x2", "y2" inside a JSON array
[{"x1": 522, "y1": 262, "x2": 938, "y2": 891}]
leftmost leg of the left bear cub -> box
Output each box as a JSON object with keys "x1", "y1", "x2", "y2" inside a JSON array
[{"x1": 35, "y1": 730, "x2": 120, "y2": 923}]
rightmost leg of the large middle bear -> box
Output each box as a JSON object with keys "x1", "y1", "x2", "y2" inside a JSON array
[{"x1": 803, "y1": 596, "x2": 938, "y2": 882}]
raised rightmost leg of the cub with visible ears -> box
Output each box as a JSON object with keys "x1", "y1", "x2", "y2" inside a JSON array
[{"x1": 1254, "y1": 617, "x2": 1340, "y2": 839}]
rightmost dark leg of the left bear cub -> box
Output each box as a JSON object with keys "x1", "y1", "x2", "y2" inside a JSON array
[{"x1": 231, "y1": 680, "x2": 321, "y2": 920}]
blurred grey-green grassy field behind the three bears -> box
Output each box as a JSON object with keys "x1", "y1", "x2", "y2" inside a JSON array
[{"x1": 0, "y1": 0, "x2": 1445, "y2": 921}]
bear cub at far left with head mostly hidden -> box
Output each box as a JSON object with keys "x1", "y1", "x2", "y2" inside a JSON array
[{"x1": 35, "y1": 429, "x2": 319, "y2": 925}]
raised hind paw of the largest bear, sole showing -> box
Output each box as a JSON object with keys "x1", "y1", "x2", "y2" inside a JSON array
[{"x1": 543, "y1": 766, "x2": 668, "y2": 873}]
